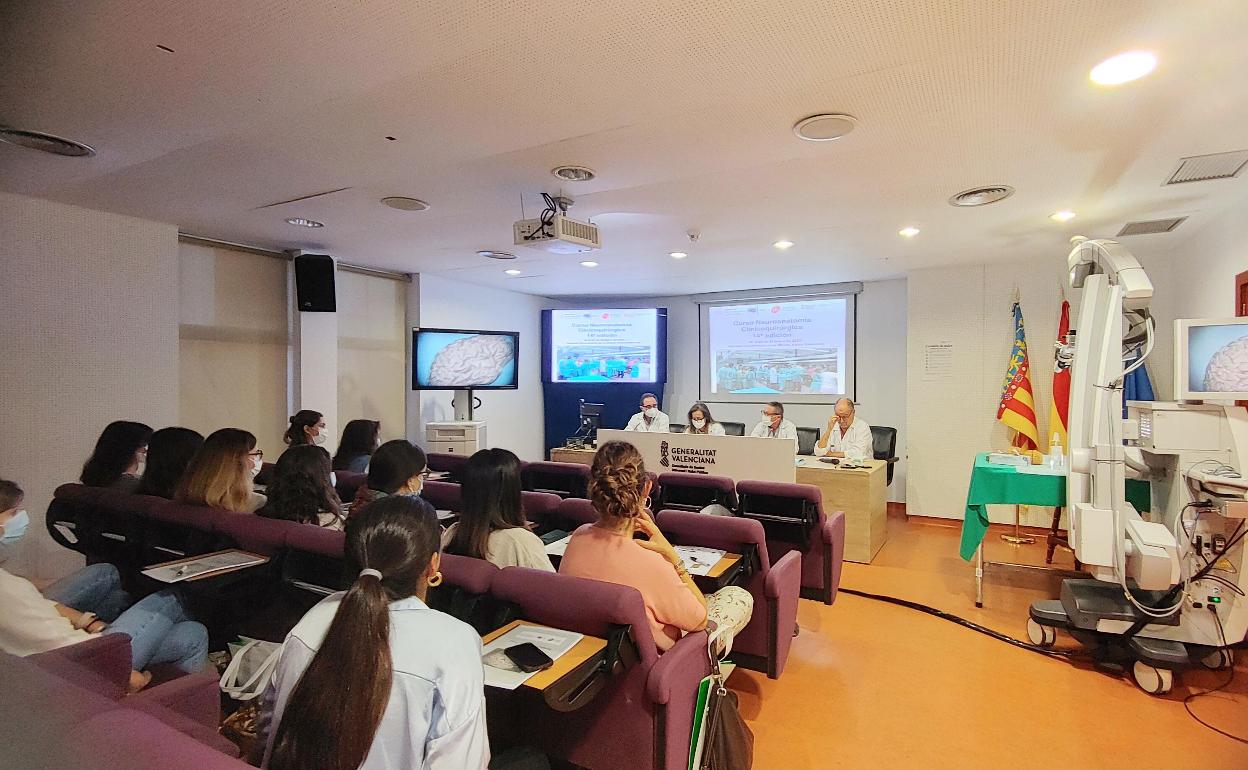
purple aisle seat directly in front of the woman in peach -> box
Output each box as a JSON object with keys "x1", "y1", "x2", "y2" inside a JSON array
[{"x1": 655, "y1": 510, "x2": 801, "y2": 679}]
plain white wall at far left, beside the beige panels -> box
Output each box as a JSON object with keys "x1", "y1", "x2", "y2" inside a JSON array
[{"x1": 0, "y1": 193, "x2": 178, "y2": 578}]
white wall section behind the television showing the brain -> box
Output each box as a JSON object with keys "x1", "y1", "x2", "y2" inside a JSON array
[{"x1": 408, "y1": 275, "x2": 547, "y2": 461}]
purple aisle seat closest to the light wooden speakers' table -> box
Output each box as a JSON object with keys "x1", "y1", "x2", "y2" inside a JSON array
[{"x1": 736, "y1": 480, "x2": 845, "y2": 604}]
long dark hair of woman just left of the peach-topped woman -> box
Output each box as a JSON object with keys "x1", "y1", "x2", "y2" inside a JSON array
[{"x1": 447, "y1": 449, "x2": 529, "y2": 559}]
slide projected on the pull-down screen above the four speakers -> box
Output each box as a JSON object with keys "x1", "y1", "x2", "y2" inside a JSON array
[{"x1": 704, "y1": 297, "x2": 850, "y2": 397}]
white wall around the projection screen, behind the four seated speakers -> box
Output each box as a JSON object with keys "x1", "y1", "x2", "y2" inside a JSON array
[{"x1": 547, "y1": 280, "x2": 907, "y2": 500}]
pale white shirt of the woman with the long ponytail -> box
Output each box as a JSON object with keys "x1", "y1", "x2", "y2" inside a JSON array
[{"x1": 262, "y1": 593, "x2": 489, "y2": 770}]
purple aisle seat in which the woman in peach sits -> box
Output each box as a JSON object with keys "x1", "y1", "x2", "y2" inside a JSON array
[{"x1": 492, "y1": 567, "x2": 710, "y2": 770}]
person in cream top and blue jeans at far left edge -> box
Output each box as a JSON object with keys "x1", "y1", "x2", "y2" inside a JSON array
[{"x1": 0, "y1": 480, "x2": 208, "y2": 691}]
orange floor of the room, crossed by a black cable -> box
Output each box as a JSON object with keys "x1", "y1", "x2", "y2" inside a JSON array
[{"x1": 729, "y1": 517, "x2": 1248, "y2": 770}]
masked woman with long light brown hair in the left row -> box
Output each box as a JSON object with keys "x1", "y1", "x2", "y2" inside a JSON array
[{"x1": 173, "y1": 428, "x2": 267, "y2": 513}]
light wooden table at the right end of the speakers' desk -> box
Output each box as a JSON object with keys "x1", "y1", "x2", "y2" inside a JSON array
[{"x1": 797, "y1": 457, "x2": 889, "y2": 564}]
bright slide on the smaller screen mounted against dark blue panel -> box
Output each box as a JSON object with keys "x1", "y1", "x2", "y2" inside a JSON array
[{"x1": 550, "y1": 308, "x2": 659, "y2": 382}]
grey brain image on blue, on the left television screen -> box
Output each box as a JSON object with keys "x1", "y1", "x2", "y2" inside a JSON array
[{"x1": 414, "y1": 331, "x2": 515, "y2": 388}]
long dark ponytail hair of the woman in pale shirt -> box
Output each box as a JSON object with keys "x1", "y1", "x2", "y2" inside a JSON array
[{"x1": 268, "y1": 497, "x2": 439, "y2": 770}]
